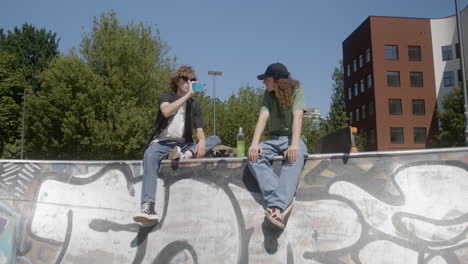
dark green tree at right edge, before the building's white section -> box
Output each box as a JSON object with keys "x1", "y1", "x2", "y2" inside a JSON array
[{"x1": 432, "y1": 87, "x2": 465, "y2": 147}]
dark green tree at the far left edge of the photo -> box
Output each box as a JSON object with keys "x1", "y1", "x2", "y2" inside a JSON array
[{"x1": 0, "y1": 24, "x2": 58, "y2": 158}]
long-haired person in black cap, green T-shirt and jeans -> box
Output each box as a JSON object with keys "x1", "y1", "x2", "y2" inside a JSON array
[{"x1": 248, "y1": 63, "x2": 307, "y2": 229}]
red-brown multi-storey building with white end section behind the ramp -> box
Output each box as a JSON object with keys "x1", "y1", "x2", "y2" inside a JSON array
[{"x1": 343, "y1": 8, "x2": 468, "y2": 150}]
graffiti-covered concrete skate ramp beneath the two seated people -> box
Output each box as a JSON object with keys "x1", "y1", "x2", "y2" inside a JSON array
[{"x1": 0, "y1": 148, "x2": 468, "y2": 264}]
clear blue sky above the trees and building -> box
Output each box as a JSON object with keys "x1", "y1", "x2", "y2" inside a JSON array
[{"x1": 0, "y1": 0, "x2": 468, "y2": 116}]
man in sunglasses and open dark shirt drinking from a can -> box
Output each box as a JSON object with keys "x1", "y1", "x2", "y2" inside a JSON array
[{"x1": 133, "y1": 66, "x2": 221, "y2": 223}]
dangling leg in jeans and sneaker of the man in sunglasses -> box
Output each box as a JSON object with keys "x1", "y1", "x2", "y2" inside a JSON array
[{"x1": 137, "y1": 141, "x2": 175, "y2": 222}]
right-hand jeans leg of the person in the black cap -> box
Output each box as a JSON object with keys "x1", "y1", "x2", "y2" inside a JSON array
[{"x1": 268, "y1": 137, "x2": 307, "y2": 210}]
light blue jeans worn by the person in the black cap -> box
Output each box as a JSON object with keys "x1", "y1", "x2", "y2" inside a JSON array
[{"x1": 248, "y1": 136, "x2": 307, "y2": 210}]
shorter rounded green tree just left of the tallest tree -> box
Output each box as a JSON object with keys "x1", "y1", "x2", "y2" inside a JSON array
[{"x1": 26, "y1": 56, "x2": 107, "y2": 159}]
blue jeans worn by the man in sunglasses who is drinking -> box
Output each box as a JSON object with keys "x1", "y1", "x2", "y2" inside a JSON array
[{"x1": 141, "y1": 136, "x2": 221, "y2": 203}]
